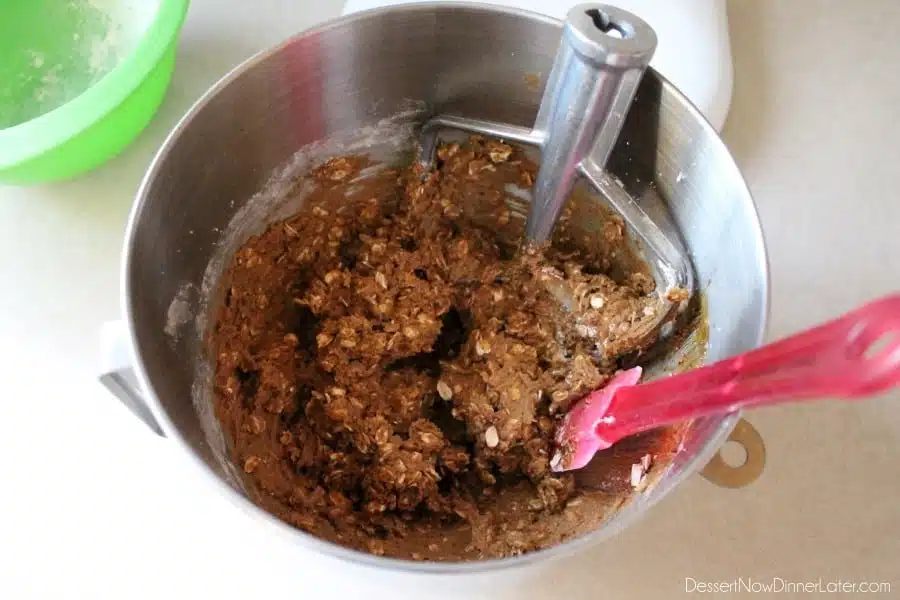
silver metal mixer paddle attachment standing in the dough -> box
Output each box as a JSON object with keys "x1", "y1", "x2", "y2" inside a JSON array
[{"x1": 420, "y1": 4, "x2": 695, "y2": 326}]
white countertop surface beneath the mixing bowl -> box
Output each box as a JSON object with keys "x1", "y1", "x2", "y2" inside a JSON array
[{"x1": 0, "y1": 0, "x2": 900, "y2": 600}]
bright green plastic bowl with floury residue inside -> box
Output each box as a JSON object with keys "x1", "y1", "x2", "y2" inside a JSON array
[{"x1": 0, "y1": 0, "x2": 189, "y2": 184}]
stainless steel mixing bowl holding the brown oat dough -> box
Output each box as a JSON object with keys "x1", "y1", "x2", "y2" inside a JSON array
[{"x1": 104, "y1": 2, "x2": 768, "y2": 573}]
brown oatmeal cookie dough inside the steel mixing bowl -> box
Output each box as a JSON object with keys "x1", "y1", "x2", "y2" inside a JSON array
[{"x1": 211, "y1": 138, "x2": 675, "y2": 560}]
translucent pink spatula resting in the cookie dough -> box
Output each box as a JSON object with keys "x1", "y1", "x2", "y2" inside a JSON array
[{"x1": 550, "y1": 295, "x2": 900, "y2": 471}]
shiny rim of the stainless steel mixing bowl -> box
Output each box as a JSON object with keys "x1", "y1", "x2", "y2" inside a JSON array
[{"x1": 120, "y1": 0, "x2": 771, "y2": 577}]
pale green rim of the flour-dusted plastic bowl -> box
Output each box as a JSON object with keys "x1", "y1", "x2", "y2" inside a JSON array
[{"x1": 0, "y1": 0, "x2": 190, "y2": 171}]
